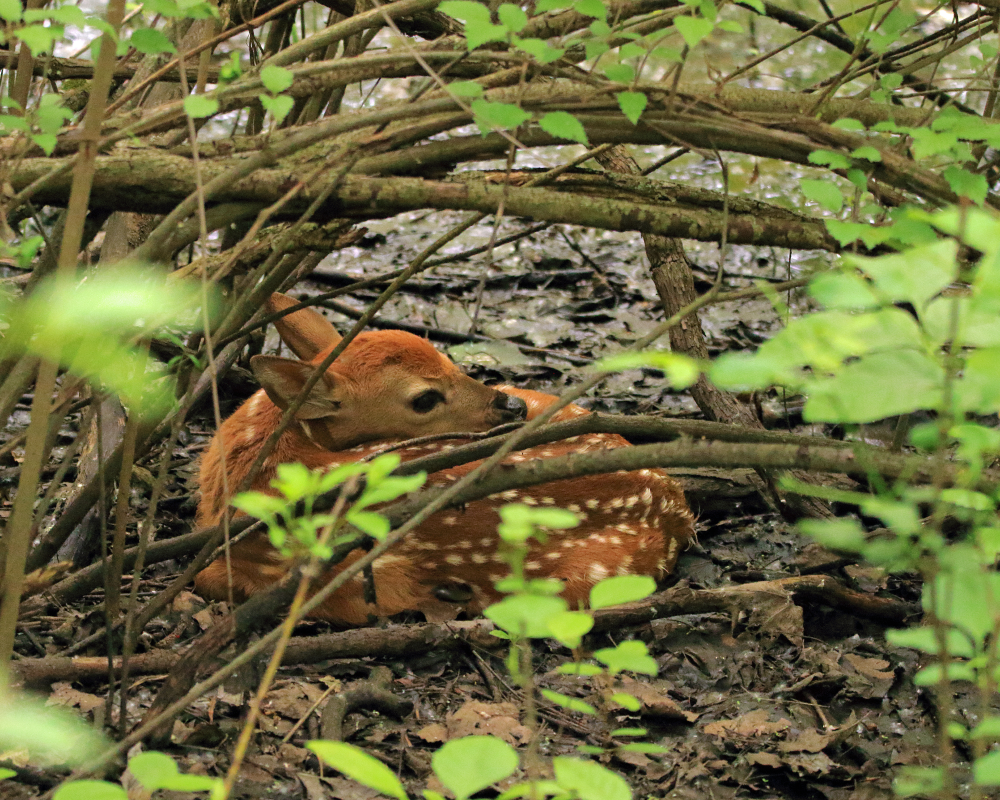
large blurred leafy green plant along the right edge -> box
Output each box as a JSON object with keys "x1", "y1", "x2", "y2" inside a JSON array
[{"x1": 696, "y1": 207, "x2": 1000, "y2": 796}]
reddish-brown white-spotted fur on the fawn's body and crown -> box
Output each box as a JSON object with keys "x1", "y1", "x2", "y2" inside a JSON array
[{"x1": 196, "y1": 296, "x2": 693, "y2": 625}]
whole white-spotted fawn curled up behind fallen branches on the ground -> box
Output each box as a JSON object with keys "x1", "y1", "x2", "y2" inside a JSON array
[{"x1": 196, "y1": 294, "x2": 694, "y2": 625}]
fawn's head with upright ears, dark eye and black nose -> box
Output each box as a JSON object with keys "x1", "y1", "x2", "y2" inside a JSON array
[{"x1": 250, "y1": 294, "x2": 526, "y2": 451}]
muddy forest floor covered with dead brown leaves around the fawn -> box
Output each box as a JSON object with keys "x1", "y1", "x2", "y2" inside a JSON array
[{"x1": 0, "y1": 209, "x2": 936, "y2": 800}]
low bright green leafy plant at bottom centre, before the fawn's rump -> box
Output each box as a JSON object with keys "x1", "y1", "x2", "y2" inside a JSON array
[{"x1": 308, "y1": 503, "x2": 664, "y2": 800}]
